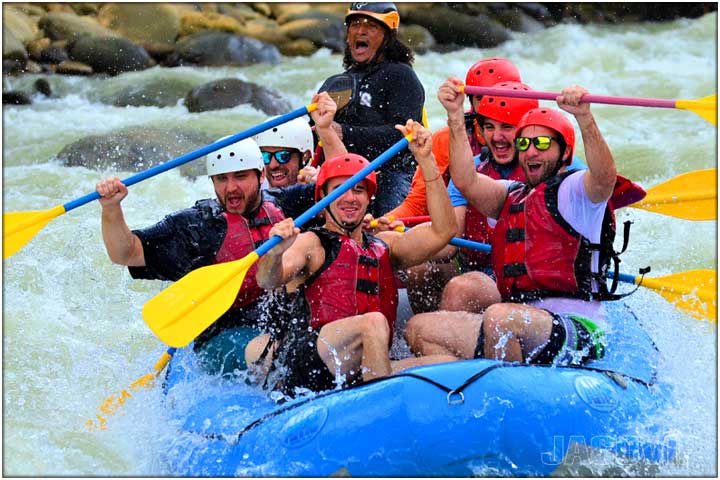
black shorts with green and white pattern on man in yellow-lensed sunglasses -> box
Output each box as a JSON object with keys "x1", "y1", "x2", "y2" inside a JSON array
[{"x1": 475, "y1": 312, "x2": 603, "y2": 365}]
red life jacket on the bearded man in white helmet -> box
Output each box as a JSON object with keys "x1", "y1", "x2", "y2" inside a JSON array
[{"x1": 215, "y1": 202, "x2": 285, "y2": 308}]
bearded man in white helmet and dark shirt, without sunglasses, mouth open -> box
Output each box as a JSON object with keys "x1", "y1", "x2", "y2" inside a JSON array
[{"x1": 96, "y1": 94, "x2": 343, "y2": 373}]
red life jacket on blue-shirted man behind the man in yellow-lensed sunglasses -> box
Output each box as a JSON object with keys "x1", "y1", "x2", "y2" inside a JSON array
[{"x1": 463, "y1": 152, "x2": 525, "y2": 270}]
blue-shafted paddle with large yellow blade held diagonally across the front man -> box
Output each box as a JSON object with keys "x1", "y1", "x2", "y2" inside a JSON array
[{"x1": 142, "y1": 135, "x2": 411, "y2": 347}]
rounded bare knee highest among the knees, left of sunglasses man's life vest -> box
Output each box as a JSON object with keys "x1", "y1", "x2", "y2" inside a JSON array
[{"x1": 440, "y1": 272, "x2": 502, "y2": 313}]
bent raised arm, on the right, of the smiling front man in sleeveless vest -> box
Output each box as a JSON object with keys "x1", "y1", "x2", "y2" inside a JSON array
[{"x1": 378, "y1": 120, "x2": 457, "y2": 268}]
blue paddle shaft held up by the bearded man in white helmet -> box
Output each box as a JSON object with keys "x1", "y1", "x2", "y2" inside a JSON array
[{"x1": 63, "y1": 106, "x2": 308, "y2": 212}]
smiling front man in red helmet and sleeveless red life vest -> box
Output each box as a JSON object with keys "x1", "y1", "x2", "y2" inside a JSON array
[{"x1": 248, "y1": 120, "x2": 455, "y2": 395}]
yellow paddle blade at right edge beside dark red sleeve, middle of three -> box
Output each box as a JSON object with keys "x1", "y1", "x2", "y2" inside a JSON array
[{"x1": 631, "y1": 168, "x2": 717, "y2": 220}]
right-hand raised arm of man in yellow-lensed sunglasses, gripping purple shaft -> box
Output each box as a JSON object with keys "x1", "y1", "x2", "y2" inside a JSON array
[{"x1": 557, "y1": 85, "x2": 617, "y2": 203}]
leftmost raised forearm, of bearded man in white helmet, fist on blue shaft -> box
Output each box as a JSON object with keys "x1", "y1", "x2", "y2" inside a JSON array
[{"x1": 95, "y1": 177, "x2": 145, "y2": 267}]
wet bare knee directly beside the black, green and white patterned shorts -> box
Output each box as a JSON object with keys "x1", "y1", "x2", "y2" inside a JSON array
[{"x1": 483, "y1": 303, "x2": 553, "y2": 362}]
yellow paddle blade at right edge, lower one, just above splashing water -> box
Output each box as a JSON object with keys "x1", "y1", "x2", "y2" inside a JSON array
[{"x1": 635, "y1": 270, "x2": 717, "y2": 322}]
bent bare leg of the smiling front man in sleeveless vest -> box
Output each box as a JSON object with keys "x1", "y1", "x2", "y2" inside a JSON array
[{"x1": 317, "y1": 312, "x2": 391, "y2": 381}]
